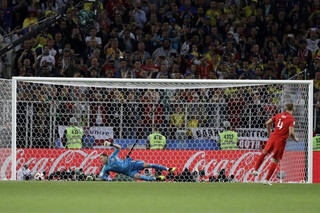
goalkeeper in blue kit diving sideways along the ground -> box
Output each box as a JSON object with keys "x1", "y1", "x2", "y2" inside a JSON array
[{"x1": 99, "y1": 141, "x2": 175, "y2": 181}]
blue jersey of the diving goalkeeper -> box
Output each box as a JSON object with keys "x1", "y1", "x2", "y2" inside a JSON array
[{"x1": 99, "y1": 149, "x2": 132, "y2": 178}]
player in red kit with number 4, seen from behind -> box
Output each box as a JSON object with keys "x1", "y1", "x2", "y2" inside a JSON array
[{"x1": 252, "y1": 103, "x2": 298, "y2": 185}]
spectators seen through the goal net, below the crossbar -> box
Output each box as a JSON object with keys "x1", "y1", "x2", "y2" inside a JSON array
[{"x1": 17, "y1": 83, "x2": 307, "y2": 147}]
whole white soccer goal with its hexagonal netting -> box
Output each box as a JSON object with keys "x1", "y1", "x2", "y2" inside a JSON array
[{"x1": 0, "y1": 77, "x2": 313, "y2": 183}]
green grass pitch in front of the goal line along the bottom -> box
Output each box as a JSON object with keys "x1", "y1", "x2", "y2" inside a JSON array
[{"x1": 0, "y1": 181, "x2": 320, "y2": 213}]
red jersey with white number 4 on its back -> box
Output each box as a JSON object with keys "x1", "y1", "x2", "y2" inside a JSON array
[{"x1": 272, "y1": 112, "x2": 295, "y2": 139}]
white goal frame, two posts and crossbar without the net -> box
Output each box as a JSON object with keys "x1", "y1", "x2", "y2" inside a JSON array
[{"x1": 11, "y1": 77, "x2": 314, "y2": 183}]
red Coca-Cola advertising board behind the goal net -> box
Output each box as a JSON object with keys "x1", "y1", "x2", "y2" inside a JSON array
[{"x1": 0, "y1": 149, "x2": 305, "y2": 182}]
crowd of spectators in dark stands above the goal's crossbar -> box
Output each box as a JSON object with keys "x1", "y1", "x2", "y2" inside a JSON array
[{"x1": 0, "y1": 0, "x2": 320, "y2": 131}]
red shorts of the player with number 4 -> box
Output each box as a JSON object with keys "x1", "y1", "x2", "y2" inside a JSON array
[{"x1": 264, "y1": 136, "x2": 287, "y2": 160}]
